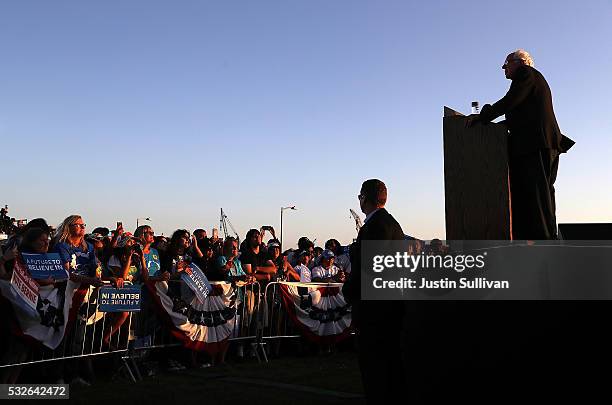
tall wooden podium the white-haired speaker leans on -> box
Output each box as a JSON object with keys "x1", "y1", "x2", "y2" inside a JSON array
[{"x1": 443, "y1": 107, "x2": 512, "y2": 240}]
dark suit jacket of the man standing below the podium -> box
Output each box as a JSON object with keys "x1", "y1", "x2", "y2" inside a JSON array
[{"x1": 342, "y1": 208, "x2": 404, "y2": 318}]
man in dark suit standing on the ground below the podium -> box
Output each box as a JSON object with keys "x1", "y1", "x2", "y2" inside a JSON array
[{"x1": 342, "y1": 179, "x2": 405, "y2": 403}]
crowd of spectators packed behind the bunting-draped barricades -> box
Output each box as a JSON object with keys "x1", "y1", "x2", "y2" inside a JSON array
[{"x1": 0, "y1": 210, "x2": 351, "y2": 383}]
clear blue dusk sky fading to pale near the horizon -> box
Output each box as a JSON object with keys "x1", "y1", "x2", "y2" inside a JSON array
[{"x1": 0, "y1": 0, "x2": 612, "y2": 247}]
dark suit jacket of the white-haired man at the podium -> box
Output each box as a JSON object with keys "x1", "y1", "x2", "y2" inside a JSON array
[{"x1": 480, "y1": 66, "x2": 573, "y2": 156}]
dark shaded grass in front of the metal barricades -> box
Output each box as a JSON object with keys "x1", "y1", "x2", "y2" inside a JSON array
[{"x1": 70, "y1": 351, "x2": 365, "y2": 405}]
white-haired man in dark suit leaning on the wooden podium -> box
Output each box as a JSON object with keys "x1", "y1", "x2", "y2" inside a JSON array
[{"x1": 468, "y1": 49, "x2": 574, "y2": 240}]
